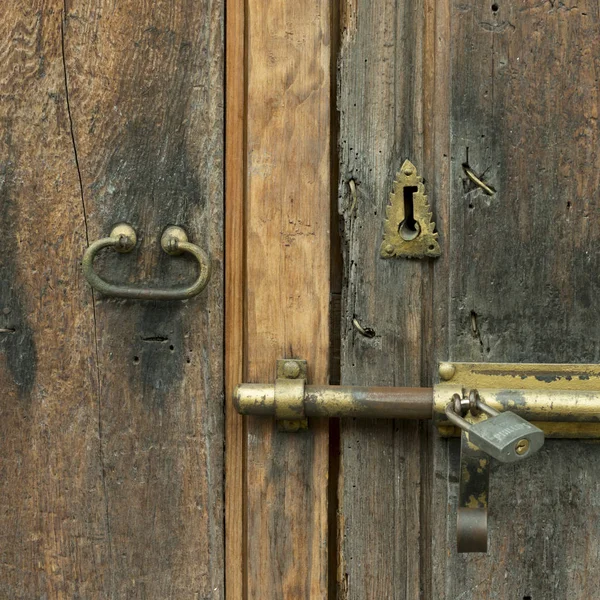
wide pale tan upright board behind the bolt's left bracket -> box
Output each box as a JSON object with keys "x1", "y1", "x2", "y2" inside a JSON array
[{"x1": 245, "y1": 0, "x2": 331, "y2": 600}]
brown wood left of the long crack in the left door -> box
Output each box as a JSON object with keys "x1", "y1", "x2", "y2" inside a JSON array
[{"x1": 0, "y1": 1, "x2": 110, "y2": 600}]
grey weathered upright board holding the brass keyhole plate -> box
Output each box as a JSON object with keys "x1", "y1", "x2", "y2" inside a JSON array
[{"x1": 338, "y1": 0, "x2": 435, "y2": 600}]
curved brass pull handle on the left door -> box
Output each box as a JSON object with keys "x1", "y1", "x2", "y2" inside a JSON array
[{"x1": 82, "y1": 223, "x2": 211, "y2": 300}]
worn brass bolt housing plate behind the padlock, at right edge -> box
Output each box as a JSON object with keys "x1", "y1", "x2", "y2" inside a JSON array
[{"x1": 433, "y1": 363, "x2": 600, "y2": 439}]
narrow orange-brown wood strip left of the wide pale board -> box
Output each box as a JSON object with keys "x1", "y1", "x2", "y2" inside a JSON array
[{"x1": 225, "y1": 0, "x2": 246, "y2": 600}]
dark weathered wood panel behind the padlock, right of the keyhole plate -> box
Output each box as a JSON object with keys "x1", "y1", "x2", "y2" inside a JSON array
[{"x1": 432, "y1": 0, "x2": 600, "y2": 600}]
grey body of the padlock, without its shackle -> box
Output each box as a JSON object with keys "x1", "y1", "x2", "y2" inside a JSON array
[{"x1": 469, "y1": 411, "x2": 544, "y2": 462}]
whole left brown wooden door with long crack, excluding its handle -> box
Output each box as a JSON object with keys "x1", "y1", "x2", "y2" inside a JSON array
[{"x1": 0, "y1": 0, "x2": 224, "y2": 600}]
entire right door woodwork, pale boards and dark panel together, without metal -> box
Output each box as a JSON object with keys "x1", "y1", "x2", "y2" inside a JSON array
[{"x1": 227, "y1": 0, "x2": 600, "y2": 600}]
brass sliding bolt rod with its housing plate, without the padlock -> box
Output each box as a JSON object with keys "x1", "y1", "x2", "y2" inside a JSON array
[{"x1": 234, "y1": 360, "x2": 600, "y2": 439}]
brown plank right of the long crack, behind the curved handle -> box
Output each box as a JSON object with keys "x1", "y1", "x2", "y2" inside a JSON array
[{"x1": 64, "y1": 0, "x2": 224, "y2": 598}]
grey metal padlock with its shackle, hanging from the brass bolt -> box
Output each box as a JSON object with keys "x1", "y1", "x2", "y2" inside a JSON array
[{"x1": 446, "y1": 390, "x2": 544, "y2": 463}]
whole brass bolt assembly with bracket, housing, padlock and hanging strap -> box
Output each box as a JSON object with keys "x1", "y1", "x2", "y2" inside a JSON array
[{"x1": 234, "y1": 359, "x2": 600, "y2": 552}]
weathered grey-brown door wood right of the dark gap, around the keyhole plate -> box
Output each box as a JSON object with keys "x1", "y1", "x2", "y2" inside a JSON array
[{"x1": 338, "y1": 0, "x2": 600, "y2": 600}]
